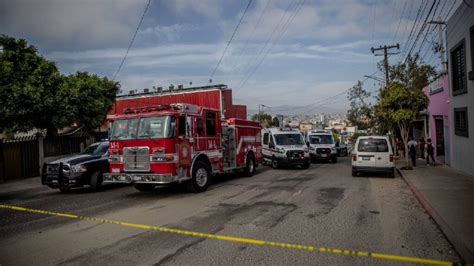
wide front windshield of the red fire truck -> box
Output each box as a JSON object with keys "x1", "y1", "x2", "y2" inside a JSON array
[{"x1": 110, "y1": 116, "x2": 176, "y2": 140}]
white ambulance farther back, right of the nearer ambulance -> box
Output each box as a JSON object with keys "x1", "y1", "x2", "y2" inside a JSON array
[{"x1": 306, "y1": 130, "x2": 337, "y2": 163}]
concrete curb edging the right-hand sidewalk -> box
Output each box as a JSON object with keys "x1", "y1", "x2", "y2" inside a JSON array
[{"x1": 395, "y1": 167, "x2": 474, "y2": 264}]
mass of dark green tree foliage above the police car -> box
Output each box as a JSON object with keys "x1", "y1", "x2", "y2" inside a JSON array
[{"x1": 0, "y1": 35, "x2": 120, "y2": 135}]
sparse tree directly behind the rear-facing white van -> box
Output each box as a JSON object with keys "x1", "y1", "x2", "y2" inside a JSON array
[{"x1": 347, "y1": 81, "x2": 373, "y2": 129}]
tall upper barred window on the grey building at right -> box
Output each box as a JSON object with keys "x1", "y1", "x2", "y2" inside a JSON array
[{"x1": 451, "y1": 39, "x2": 467, "y2": 96}]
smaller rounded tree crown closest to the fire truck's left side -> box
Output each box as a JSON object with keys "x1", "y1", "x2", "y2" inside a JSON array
[{"x1": 61, "y1": 72, "x2": 120, "y2": 129}]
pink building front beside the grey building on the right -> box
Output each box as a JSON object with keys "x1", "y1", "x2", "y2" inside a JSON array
[{"x1": 423, "y1": 75, "x2": 452, "y2": 165}]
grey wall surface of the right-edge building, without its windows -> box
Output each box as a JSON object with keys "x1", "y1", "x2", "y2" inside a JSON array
[{"x1": 446, "y1": 4, "x2": 474, "y2": 173}]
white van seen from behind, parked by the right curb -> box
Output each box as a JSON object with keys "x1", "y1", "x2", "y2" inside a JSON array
[{"x1": 352, "y1": 136, "x2": 395, "y2": 177}]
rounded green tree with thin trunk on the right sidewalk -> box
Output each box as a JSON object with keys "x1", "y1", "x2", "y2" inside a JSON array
[{"x1": 378, "y1": 82, "x2": 429, "y2": 166}]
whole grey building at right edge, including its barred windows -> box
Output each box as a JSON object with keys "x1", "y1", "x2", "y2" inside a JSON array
[{"x1": 446, "y1": 4, "x2": 474, "y2": 174}]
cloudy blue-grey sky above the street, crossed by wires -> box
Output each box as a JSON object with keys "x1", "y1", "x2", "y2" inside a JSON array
[{"x1": 0, "y1": 0, "x2": 461, "y2": 113}]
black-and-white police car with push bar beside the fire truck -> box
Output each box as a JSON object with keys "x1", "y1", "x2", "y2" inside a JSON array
[{"x1": 41, "y1": 141, "x2": 109, "y2": 192}]
